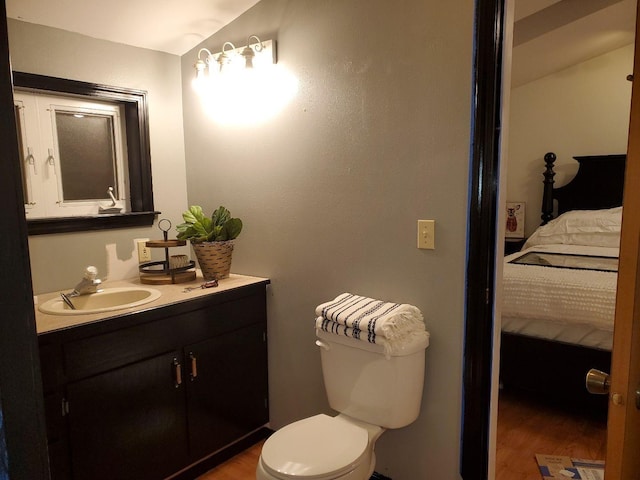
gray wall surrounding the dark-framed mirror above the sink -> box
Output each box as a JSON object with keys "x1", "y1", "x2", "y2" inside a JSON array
[{"x1": 8, "y1": 19, "x2": 187, "y2": 294}]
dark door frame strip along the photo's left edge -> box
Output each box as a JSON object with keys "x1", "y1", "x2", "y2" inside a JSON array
[{"x1": 0, "y1": 0, "x2": 49, "y2": 480}]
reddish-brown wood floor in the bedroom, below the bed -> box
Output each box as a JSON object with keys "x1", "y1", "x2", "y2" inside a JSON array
[{"x1": 496, "y1": 391, "x2": 607, "y2": 480}]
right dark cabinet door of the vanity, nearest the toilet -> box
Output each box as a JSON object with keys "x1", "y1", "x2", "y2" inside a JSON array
[{"x1": 185, "y1": 324, "x2": 269, "y2": 460}]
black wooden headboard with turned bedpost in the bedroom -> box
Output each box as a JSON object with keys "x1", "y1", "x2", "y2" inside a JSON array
[{"x1": 541, "y1": 152, "x2": 627, "y2": 225}]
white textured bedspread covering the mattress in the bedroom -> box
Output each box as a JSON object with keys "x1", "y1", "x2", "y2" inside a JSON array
[{"x1": 501, "y1": 244, "x2": 618, "y2": 350}]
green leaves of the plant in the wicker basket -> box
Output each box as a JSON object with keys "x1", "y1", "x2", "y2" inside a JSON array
[{"x1": 176, "y1": 205, "x2": 242, "y2": 243}]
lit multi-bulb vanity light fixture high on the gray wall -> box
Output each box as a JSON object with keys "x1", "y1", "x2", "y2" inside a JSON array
[{"x1": 194, "y1": 35, "x2": 276, "y2": 81}]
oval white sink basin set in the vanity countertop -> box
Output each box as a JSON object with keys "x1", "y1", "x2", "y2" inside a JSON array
[{"x1": 38, "y1": 287, "x2": 160, "y2": 315}]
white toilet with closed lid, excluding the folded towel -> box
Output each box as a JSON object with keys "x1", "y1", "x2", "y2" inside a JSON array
[{"x1": 256, "y1": 329, "x2": 429, "y2": 480}]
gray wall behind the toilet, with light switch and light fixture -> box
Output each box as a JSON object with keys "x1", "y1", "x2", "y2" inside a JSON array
[{"x1": 182, "y1": 0, "x2": 473, "y2": 480}]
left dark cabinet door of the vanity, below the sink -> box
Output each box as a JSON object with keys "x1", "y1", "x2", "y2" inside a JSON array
[{"x1": 67, "y1": 352, "x2": 187, "y2": 480}]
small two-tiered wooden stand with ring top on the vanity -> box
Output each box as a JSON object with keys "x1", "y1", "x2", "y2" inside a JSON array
[{"x1": 138, "y1": 219, "x2": 196, "y2": 285}]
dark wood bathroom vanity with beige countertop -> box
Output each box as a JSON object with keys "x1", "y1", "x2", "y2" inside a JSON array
[{"x1": 36, "y1": 275, "x2": 269, "y2": 480}]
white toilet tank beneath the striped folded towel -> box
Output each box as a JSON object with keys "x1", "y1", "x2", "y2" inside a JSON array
[{"x1": 316, "y1": 329, "x2": 429, "y2": 428}]
